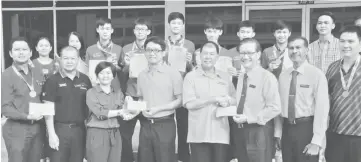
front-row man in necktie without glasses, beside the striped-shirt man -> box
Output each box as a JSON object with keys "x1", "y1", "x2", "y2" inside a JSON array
[{"x1": 275, "y1": 37, "x2": 330, "y2": 162}]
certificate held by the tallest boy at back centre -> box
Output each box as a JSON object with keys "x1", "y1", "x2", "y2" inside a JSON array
[{"x1": 168, "y1": 46, "x2": 187, "y2": 72}]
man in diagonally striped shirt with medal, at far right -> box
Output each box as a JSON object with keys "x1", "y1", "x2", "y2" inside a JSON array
[{"x1": 326, "y1": 26, "x2": 361, "y2": 162}]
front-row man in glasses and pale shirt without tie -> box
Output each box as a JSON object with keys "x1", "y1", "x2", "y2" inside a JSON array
[{"x1": 137, "y1": 37, "x2": 183, "y2": 162}]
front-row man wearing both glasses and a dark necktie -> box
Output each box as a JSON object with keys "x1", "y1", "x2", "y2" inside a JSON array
[{"x1": 231, "y1": 38, "x2": 281, "y2": 162}]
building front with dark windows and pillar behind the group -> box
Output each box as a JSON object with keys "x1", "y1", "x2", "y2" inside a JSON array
[{"x1": 0, "y1": 0, "x2": 361, "y2": 70}]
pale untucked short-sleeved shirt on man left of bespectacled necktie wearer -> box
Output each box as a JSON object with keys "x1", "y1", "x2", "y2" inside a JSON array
[{"x1": 183, "y1": 68, "x2": 235, "y2": 144}]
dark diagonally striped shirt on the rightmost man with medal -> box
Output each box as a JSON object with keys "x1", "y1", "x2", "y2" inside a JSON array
[{"x1": 326, "y1": 60, "x2": 361, "y2": 136}]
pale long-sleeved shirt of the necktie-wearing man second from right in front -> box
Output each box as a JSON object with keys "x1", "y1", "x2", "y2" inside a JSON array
[{"x1": 275, "y1": 61, "x2": 330, "y2": 146}]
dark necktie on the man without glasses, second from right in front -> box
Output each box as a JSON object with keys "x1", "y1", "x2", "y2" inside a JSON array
[{"x1": 288, "y1": 71, "x2": 298, "y2": 123}]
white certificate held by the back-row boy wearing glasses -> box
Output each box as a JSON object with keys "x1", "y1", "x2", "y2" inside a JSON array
[{"x1": 129, "y1": 53, "x2": 148, "y2": 78}]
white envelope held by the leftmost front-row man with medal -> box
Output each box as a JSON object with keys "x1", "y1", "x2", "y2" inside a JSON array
[{"x1": 29, "y1": 102, "x2": 55, "y2": 115}]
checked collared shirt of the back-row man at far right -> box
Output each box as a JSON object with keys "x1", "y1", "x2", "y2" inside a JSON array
[{"x1": 308, "y1": 36, "x2": 341, "y2": 73}]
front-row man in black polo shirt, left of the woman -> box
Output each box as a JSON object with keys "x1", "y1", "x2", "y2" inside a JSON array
[{"x1": 42, "y1": 46, "x2": 92, "y2": 162}]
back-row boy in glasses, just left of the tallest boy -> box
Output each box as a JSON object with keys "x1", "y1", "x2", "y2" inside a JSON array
[{"x1": 119, "y1": 18, "x2": 151, "y2": 162}]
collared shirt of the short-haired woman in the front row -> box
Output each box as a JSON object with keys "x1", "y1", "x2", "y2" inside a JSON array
[{"x1": 86, "y1": 85, "x2": 124, "y2": 128}]
